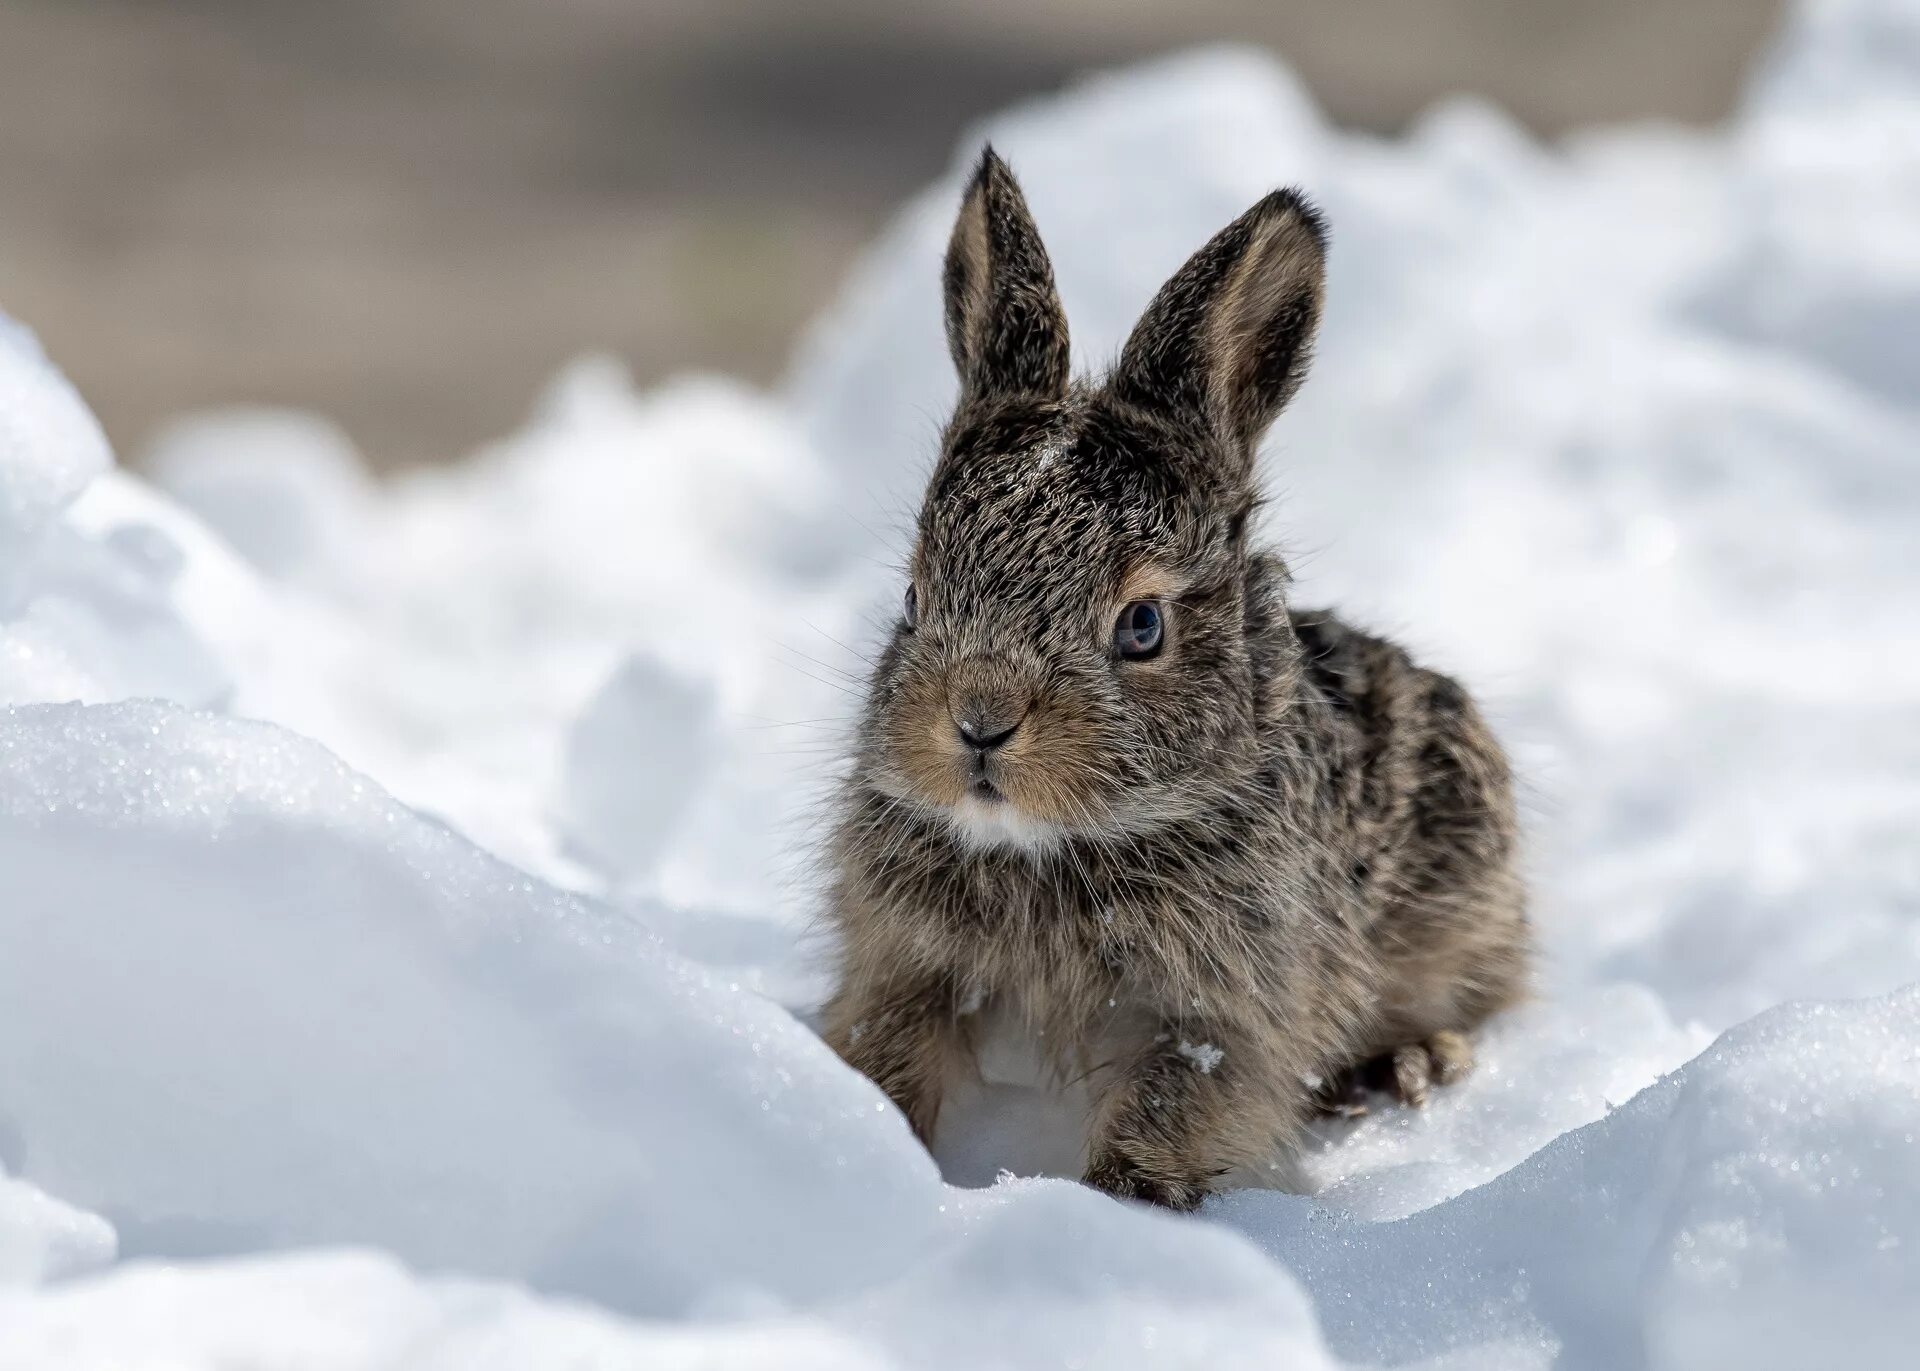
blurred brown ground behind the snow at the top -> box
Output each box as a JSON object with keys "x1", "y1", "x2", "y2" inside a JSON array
[{"x1": 0, "y1": 0, "x2": 1778, "y2": 467}]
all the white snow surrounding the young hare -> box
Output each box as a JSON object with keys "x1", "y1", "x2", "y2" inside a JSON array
[{"x1": 0, "y1": 0, "x2": 1920, "y2": 1371}]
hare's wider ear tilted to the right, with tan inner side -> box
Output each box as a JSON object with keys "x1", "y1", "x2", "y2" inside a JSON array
[{"x1": 1108, "y1": 190, "x2": 1327, "y2": 451}]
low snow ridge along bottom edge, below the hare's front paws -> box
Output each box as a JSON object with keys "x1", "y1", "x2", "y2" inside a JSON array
[{"x1": 0, "y1": 1187, "x2": 1336, "y2": 1371}]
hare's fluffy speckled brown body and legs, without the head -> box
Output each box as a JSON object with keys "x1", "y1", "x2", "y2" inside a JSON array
[{"x1": 828, "y1": 576, "x2": 1528, "y2": 1202}]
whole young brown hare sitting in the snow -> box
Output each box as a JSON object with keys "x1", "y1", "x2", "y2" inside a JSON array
[{"x1": 824, "y1": 148, "x2": 1530, "y2": 1210}]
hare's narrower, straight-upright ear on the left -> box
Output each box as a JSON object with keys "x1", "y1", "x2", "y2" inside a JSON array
[{"x1": 943, "y1": 148, "x2": 1068, "y2": 397}]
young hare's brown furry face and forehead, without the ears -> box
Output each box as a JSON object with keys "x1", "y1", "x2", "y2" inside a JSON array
[{"x1": 868, "y1": 396, "x2": 1254, "y2": 847}]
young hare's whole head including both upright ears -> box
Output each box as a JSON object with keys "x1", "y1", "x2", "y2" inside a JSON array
[{"x1": 862, "y1": 150, "x2": 1325, "y2": 849}]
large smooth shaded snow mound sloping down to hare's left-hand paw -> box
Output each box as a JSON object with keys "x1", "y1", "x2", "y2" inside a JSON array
[{"x1": 0, "y1": 703, "x2": 931, "y2": 1311}]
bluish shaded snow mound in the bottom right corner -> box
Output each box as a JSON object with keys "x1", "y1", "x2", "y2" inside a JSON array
[{"x1": 1221, "y1": 987, "x2": 1920, "y2": 1371}]
